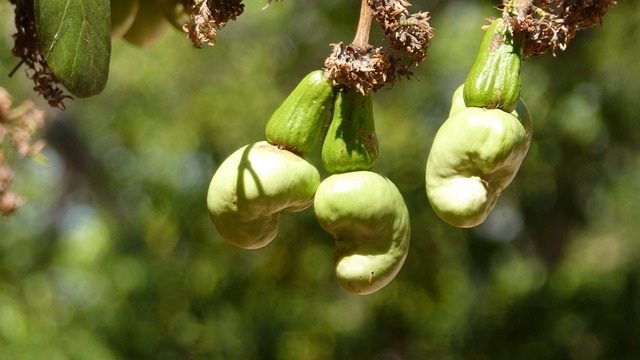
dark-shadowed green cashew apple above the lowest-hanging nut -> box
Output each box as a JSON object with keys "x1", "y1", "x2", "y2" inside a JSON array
[{"x1": 321, "y1": 88, "x2": 378, "y2": 174}]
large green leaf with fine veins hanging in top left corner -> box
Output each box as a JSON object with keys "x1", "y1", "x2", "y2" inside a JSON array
[{"x1": 35, "y1": 0, "x2": 111, "y2": 98}]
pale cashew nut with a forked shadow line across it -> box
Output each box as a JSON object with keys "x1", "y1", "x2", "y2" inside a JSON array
[{"x1": 207, "y1": 141, "x2": 320, "y2": 249}]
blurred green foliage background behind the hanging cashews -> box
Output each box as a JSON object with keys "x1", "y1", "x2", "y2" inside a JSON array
[{"x1": 0, "y1": 0, "x2": 640, "y2": 360}]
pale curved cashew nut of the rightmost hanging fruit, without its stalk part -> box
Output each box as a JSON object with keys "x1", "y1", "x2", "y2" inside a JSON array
[{"x1": 425, "y1": 107, "x2": 531, "y2": 228}]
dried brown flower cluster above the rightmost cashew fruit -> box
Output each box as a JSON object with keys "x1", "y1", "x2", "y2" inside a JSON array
[{"x1": 503, "y1": 0, "x2": 617, "y2": 59}]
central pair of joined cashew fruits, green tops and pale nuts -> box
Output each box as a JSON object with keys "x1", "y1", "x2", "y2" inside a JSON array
[{"x1": 207, "y1": 70, "x2": 411, "y2": 294}]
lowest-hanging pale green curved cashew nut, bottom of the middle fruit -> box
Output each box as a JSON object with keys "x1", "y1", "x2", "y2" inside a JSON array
[{"x1": 314, "y1": 171, "x2": 411, "y2": 294}]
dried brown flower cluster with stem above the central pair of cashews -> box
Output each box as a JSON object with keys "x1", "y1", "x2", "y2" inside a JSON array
[{"x1": 324, "y1": 0, "x2": 435, "y2": 94}]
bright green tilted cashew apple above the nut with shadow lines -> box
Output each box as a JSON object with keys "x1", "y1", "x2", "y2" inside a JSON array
[{"x1": 265, "y1": 70, "x2": 334, "y2": 154}]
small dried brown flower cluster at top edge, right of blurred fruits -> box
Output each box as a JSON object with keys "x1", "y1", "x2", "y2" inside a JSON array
[{"x1": 183, "y1": 0, "x2": 246, "y2": 48}]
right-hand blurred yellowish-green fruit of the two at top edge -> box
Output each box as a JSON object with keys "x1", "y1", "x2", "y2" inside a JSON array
[{"x1": 123, "y1": 0, "x2": 169, "y2": 48}]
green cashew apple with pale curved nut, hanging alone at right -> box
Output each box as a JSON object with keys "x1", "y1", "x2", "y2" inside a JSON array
[{"x1": 425, "y1": 18, "x2": 532, "y2": 228}]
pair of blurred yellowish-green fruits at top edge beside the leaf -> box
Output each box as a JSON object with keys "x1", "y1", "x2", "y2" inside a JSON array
[{"x1": 111, "y1": 0, "x2": 189, "y2": 48}]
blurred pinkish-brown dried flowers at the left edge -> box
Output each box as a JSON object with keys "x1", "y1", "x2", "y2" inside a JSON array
[{"x1": 0, "y1": 87, "x2": 44, "y2": 215}]
